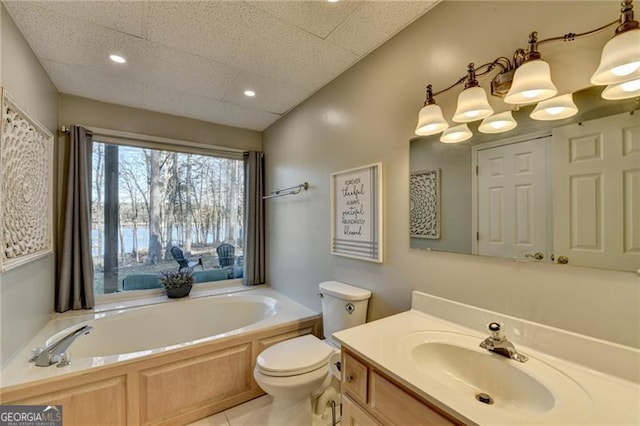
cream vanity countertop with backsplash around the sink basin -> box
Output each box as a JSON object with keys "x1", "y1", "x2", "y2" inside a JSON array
[{"x1": 334, "y1": 292, "x2": 640, "y2": 425}]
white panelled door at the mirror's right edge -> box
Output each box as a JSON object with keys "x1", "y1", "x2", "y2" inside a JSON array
[{"x1": 553, "y1": 113, "x2": 640, "y2": 271}]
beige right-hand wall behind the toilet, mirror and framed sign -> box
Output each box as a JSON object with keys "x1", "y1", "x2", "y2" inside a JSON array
[{"x1": 264, "y1": 1, "x2": 640, "y2": 347}]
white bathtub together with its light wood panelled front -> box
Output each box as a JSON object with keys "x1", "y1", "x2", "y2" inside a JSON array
[{"x1": 0, "y1": 287, "x2": 321, "y2": 425}]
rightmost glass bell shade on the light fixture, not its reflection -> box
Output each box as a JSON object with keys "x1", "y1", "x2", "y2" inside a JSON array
[{"x1": 591, "y1": 28, "x2": 640, "y2": 86}]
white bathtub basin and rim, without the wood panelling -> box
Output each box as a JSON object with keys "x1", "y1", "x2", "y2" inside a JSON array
[{"x1": 0, "y1": 287, "x2": 318, "y2": 387}]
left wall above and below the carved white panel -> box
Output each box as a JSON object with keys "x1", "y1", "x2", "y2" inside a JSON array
[{"x1": 0, "y1": 5, "x2": 58, "y2": 366}]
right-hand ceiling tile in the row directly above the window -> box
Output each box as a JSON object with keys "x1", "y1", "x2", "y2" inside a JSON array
[{"x1": 143, "y1": 86, "x2": 281, "y2": 131}]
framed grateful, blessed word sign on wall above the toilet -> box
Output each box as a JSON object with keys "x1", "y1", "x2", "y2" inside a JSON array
[{"x1": 331, "y1": 163, "x2": 383, "y2": 263}]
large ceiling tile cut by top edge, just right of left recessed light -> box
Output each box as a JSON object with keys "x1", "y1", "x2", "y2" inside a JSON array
[{"x1": 148, "y1": 2, "x2": 358, "y2": 86}]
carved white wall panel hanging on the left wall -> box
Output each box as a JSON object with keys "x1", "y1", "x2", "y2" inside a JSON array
[{"x1": 0, "y1": 89, "x2": 53, "y2": 271}]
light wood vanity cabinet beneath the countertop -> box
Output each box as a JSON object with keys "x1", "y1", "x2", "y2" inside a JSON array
[{"x1": 341, "y1": 347, "x2": 464, "y2": 426}]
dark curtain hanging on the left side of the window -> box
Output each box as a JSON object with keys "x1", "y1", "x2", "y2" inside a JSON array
[{"x1": 56, "y1": 126, "x2": 95, "y2": 312}]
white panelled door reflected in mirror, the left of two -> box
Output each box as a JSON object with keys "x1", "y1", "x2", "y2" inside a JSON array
[{"x1": 476, "y1": 137, "x2": 551, "y2": 261}]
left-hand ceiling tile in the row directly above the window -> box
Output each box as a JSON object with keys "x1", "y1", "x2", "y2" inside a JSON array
[{"x1": 42, "y1": 60, "x2": 143, "y2": 108}]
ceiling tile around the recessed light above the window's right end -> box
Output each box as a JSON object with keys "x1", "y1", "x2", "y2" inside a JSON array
[{"x1": 224, "y1": 73, "x2": 310, "y2": 114}]
